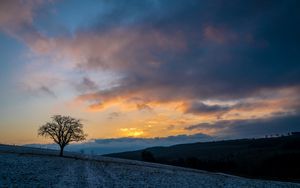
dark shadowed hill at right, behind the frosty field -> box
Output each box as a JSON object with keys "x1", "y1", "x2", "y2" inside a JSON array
[{"x1": 105, "y1": 133, "x2": 300, "y2": 182}]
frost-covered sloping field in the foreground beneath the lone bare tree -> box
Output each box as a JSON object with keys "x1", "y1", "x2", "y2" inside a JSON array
[{"x1": 0, "y1": 145, "x2": 300, "y2": 188}]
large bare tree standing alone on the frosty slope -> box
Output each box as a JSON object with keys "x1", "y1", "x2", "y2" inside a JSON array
[{"x1": 38, "y1": 115, "x2": 87, "y2": 156}]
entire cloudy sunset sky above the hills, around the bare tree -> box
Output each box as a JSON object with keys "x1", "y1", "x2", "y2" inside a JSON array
[{"x1": 0, "y1": 0, "x2": 300, "y2": 144}]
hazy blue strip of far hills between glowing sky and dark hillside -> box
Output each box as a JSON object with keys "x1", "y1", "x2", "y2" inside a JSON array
[{"x1": 20, "y1": 132, "x2": 299, "y2": 155}]
